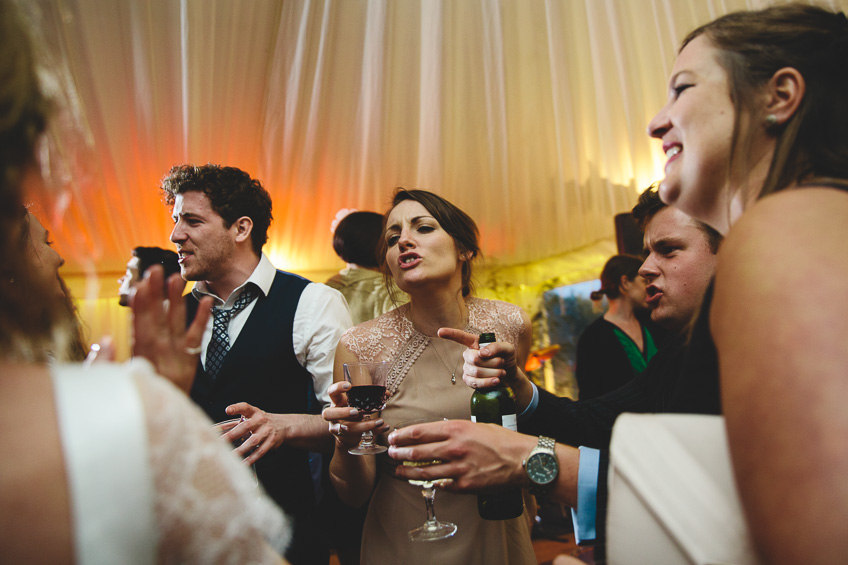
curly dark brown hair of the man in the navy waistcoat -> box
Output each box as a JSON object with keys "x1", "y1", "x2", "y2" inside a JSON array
[{"x1": 160, "y1": 163, "x2": 274, "y2": 255}]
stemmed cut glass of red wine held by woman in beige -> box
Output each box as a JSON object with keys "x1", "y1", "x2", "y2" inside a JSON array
[{"x1": 344, "y1": 361, "x2": 389, "y2": 455}]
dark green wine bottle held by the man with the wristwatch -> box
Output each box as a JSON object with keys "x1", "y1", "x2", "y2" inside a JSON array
[{"x1": 471, "y1": 333, "x2": 524, "y2": 520}]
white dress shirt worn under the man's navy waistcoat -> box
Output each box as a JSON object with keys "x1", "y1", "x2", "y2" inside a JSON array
[{"x1": 191, "y1": 253, "x2": 353, "y2": 406}]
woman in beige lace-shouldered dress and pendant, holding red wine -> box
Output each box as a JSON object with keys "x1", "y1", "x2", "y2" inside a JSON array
[{"x1": 324, "y1": 189, "x2": 536, "y2": 565}]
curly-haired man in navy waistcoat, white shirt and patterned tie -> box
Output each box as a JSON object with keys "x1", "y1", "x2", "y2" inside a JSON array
[{"x1": 161, "y1": 164, "x2": 352, "y2": 565}]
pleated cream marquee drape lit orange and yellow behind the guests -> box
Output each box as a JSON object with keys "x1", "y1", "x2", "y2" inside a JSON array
[{"x1": 24, "y1": 0, "x2": 846, "y2": 294}]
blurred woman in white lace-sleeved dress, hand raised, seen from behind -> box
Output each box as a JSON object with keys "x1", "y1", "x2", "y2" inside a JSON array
[{"x1": 0, "y1": 0, "x2": 287, "y2": 563}]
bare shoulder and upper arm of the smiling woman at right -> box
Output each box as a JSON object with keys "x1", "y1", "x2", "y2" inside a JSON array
[{"x1": 710, "y1": 187, "x2": 848, "y2": 562}]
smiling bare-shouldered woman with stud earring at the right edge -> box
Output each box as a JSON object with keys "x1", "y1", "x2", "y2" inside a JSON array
[{"x1": 649, "y1": 4, "x2": 848, "y2": 563}]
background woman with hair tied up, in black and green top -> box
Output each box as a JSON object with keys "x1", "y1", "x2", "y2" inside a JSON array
[{"x1": 576, "y1": 255, "x2": 657, "y2": 400}]
